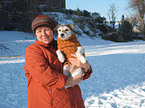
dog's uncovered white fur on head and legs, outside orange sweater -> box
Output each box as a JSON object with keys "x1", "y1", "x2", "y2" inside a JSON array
[{"x1": 55, "y1": 24, "x2": 86, "y2": 88}]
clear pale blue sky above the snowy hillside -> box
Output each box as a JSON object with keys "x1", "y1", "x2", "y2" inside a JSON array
[{"x1": 66, "y1": 0, "x2": 129, "y2": 21}]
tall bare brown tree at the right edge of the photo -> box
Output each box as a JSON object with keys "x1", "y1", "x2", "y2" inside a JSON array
[{"x1": 129, "y1": 0, "x2": 145, "y2": 41}]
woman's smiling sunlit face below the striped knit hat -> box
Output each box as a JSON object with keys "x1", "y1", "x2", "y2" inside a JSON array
[{"x1": 35, "y1": 26, "x2": 53, "y2": 44}]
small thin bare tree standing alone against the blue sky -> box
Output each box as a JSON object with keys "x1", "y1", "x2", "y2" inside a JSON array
[{"x1": 107, "y1": 4, "x2": 117, "y2": 28}]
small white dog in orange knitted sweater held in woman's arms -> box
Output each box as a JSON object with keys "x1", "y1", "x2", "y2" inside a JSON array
[{"x1": 55, "y1": 24, "x2": 86, "y2": 86}]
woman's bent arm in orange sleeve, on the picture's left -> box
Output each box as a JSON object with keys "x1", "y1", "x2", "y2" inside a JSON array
[{"x1": 25, "y1": 46, "x2": 68, "y2": 89}]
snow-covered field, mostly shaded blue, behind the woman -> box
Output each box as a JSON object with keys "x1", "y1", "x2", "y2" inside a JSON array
[{"x1": 0, "y1": 31, "x2": 145, "y2": 108}]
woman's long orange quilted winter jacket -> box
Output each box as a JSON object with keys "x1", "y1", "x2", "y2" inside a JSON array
[{"x1": 24, "y1": 41, "x2": 92, "y2": 108}]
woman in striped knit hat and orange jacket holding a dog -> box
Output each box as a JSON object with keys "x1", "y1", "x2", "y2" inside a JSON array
[{"x1": 24, "y1": 15, "x2": 92, "y2": 108}]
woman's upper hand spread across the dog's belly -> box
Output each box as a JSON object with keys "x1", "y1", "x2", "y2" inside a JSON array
[{"x1": 68, "y1": 54, "x2": 90, "y2": 72}]
